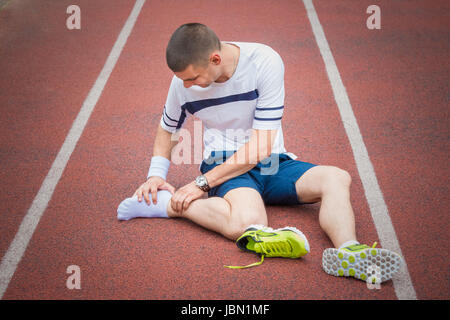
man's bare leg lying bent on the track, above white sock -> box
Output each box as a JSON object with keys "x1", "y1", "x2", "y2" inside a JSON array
[{"x1": 167, "y1": 188, "x2": 267, "y2": 240}]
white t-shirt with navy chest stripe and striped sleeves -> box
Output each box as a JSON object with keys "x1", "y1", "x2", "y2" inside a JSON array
[{"x1": 161, "y1": 42, "x2": 295, "y2": 159}]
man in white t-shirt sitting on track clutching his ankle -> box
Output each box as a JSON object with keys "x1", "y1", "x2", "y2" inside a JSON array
[{"x1": 118, "y1": 23, "x2": 400, "y2": 281}]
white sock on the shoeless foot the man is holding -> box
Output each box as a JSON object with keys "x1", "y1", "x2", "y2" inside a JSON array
[{"x1": 117, "y1": 190, "x2": 172, "y2": 220}]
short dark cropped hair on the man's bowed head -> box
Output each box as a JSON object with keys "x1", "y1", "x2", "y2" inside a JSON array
[{"x1": 166, "y1": 23, "x2": 221, "y2": 72}]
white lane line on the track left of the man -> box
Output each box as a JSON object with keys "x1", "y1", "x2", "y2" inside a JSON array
[{"x1": 0, "y1": 0, "x2": 145, "y2": 299}]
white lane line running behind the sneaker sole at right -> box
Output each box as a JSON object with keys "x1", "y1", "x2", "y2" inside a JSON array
[{"x1": 303, "y1": 0, "x2": 417, "y2": 300}]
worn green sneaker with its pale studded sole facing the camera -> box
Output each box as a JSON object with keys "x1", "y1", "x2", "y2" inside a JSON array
[{"x1": 322, "y1": 242, "x2": 402, "y2": 284}]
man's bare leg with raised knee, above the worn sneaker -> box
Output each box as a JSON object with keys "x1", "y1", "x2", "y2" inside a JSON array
[{"x1": 295, "y1": 166, "x2": 356, "y2": 248}]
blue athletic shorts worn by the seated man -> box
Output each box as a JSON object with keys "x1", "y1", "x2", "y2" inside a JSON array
[{"x1": 200, "y1": 151, "x2": 316, "y2": 205}]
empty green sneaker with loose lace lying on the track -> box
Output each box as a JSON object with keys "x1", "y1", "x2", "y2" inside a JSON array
[{"x1": 225, "y1": 225, "x2": 309, "y2": 269}]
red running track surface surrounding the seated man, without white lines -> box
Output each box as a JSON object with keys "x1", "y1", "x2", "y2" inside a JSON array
[{"x1": 0, "y1": 0, "x2": 450, "y2": 299}]
